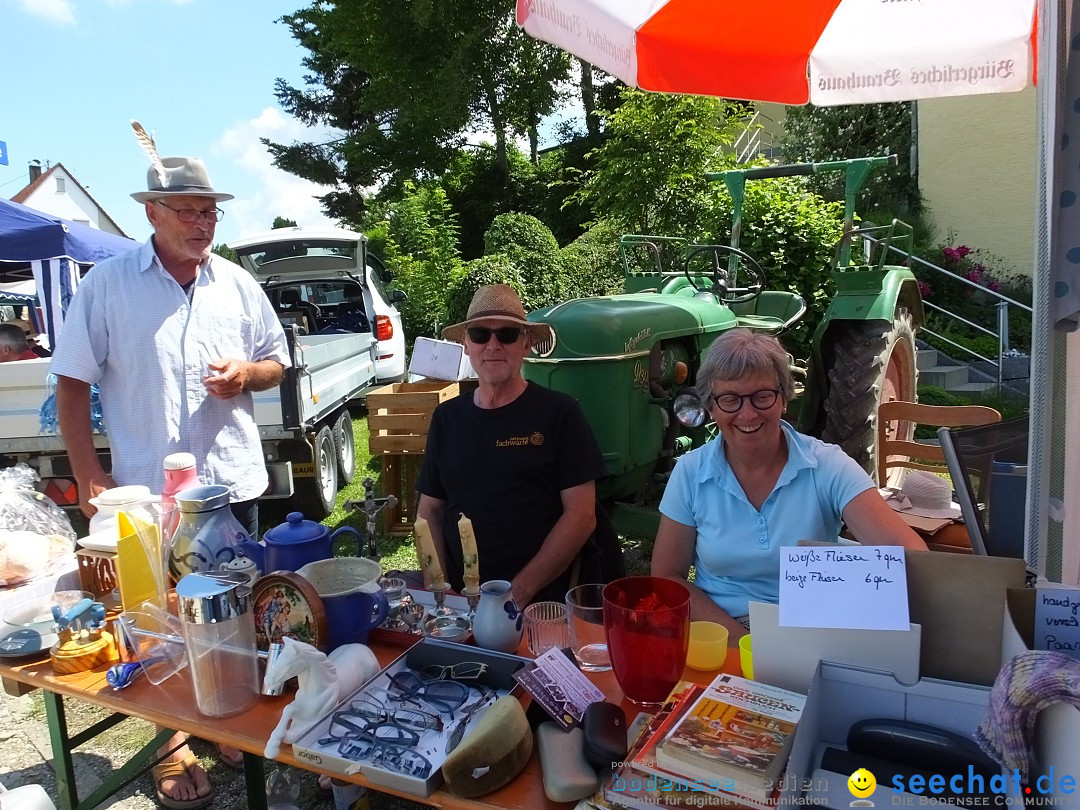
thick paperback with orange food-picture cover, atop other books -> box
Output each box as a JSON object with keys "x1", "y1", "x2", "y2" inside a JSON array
[{"x1": 656, "y1": 674, "x2": 806, "y2": 801}]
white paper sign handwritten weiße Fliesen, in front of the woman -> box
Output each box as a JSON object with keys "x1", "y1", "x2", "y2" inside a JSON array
[{"x1": 780, "y1": 545, "x2": 908, "y2": 630}]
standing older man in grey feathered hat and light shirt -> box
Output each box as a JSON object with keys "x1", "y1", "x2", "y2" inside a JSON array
[{"x1": 51, "y1": 154, "x2": 289, "y2": 808}]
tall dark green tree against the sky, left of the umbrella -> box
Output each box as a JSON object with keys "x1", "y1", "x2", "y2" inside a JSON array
[{"x1": 264, "y1": 0, "x2": 570, "y2": 222}]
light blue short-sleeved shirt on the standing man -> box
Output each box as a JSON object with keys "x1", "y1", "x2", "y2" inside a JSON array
[{"x1": 51, "y1": 241, "x2": 291, "y2": 501}]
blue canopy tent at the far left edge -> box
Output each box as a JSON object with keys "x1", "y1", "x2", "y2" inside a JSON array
[{"x1": 0, "y1": 200, "x2": 138, "y2": 346}]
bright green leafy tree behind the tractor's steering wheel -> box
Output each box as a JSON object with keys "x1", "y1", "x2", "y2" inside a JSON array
[{"x1": 569, "y1": 87, "x2": 734, "y2": 235}]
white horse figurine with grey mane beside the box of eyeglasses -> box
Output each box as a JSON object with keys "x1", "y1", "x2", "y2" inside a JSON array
[{"x1": 262, "y1": 636, "x2": 379, "y2": 759}]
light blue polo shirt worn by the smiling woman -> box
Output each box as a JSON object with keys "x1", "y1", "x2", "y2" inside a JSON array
[{"x1": 660, "y1": 421, "x2": 875, "y2": 617}]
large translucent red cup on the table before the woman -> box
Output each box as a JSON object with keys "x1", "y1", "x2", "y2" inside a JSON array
[{"x1": 604, "y1": 577, "x2": 690, "y2": 706}]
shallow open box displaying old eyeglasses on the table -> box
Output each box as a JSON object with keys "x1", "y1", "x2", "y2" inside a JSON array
[{"x1": 293, "y1": 638, "x2": 532, "y2": 796}]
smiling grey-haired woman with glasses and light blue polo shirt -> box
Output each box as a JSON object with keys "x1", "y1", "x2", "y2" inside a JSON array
[{"x1": 652, "y1": 329, "x2": 927, "y2": 639}]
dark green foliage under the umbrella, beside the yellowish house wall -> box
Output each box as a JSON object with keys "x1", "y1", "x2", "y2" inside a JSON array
[{"x1": 781, "y1": 103, "x2": 921, "y2": 218}]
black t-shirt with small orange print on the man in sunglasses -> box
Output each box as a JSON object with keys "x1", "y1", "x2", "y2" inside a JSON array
[{"x1": 417, "y1": 382, "x2": 607, "y2": 599}]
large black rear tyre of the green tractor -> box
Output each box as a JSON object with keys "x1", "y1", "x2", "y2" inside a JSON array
[{"x1": 821, "y1": 309, "x2": 918, "y2": 478}]
